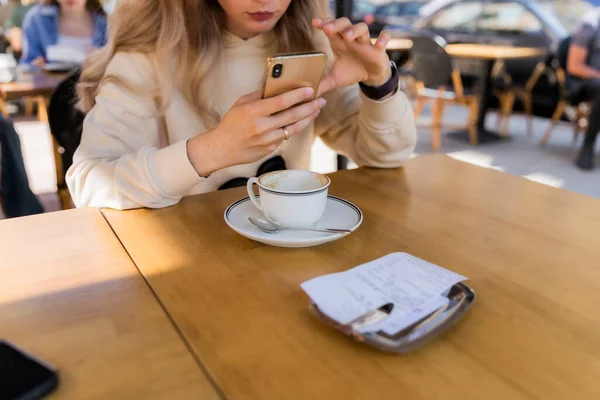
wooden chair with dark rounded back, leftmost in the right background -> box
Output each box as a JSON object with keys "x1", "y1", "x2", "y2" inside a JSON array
[{"x1": 412, "y1": 35, "x2": 479, "y2": 151}]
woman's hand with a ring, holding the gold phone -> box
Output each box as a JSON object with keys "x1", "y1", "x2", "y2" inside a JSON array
[{"x1": 188, "y1": 88, "x2": 325, "y2": 176}]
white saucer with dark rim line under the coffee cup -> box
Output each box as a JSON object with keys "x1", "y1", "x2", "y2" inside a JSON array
[{"x1": 225, "y1": 196, "x2": 363, "y2": 247}]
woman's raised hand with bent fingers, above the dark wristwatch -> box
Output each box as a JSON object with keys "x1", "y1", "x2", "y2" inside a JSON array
[{"x1": 313, "y1": 18, "x2": 392, "y2": 95}]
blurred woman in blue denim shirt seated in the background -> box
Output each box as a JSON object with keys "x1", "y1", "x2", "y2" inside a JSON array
[{"x1": 22, "y1": 0, "x2": 106, "y2": 66}]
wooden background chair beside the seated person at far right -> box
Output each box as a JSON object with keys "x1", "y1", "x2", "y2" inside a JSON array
[{"x1": 540, "y1": 37, "x2": 589, "y2": 146}]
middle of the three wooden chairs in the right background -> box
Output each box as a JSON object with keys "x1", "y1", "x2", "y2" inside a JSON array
[{"x1": 492, "y1": 60, "x2": 548, "y2": 137}]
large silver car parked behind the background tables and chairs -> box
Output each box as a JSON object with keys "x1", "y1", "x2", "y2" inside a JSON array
[{"x1": 388, "y1": 0, "x2": 591, "y2": 117}]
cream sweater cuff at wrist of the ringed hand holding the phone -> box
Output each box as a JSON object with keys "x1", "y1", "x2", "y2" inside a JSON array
[{"x1": 148, "y1": 140, "x2": 205, "y2": 198}]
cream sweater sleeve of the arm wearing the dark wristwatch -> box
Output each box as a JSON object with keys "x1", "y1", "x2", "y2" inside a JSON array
[{"x1": 315, "y1": 35, "x2": 417, "y2": 168}]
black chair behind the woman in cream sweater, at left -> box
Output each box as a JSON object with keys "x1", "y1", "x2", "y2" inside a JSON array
[{"x1": 48, "y1": 71, "x2": 85, "y2": 210}]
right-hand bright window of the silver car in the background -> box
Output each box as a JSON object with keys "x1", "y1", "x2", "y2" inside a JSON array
[{"x1": 479, "y1": 2, "x2": 543, "y2": 33}]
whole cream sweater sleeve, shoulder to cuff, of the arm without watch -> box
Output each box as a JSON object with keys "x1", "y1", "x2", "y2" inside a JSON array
[{"x1": 67, "y1": 53, "x2": 202, "y2": 209}]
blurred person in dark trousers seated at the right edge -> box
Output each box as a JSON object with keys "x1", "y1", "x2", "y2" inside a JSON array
[{"x1": 567, "y1": 7, "x2": 600, "y2": 170}]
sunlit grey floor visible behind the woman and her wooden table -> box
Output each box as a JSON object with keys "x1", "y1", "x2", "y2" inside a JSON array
[{"x1": 7, "y1": 99, "x2": 600, "y2": 220}]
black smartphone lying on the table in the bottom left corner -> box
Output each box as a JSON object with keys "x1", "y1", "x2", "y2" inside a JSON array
[{"x1": 0, "y1": 341, "x2": 58, "y2": 400}]
